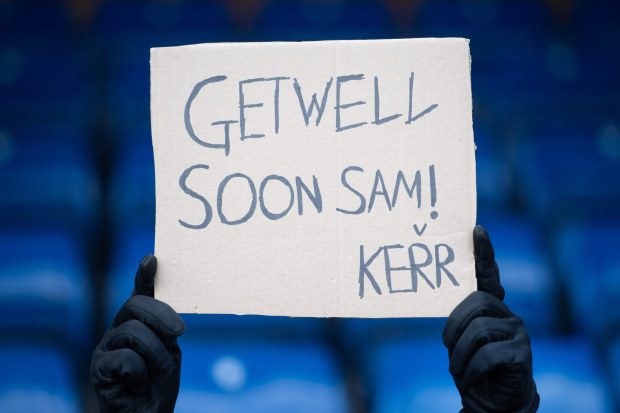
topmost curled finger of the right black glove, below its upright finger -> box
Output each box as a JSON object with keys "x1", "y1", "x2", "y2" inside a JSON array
[{"x1": 442, "y1": 291, "x2": 512, "y2": 354}]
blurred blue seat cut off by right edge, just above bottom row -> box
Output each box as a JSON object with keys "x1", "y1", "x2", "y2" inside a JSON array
[{"x1": 554, "y1": 215, "x2": 620, "y2": 334}]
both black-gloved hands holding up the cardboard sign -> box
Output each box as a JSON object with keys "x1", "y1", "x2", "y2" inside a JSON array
[{"x1": 90, "y1": 226, "x2": 539, "y2": 413}]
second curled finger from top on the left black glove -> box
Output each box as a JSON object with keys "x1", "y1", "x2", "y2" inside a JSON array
[{"x1": 104, "y1": 320, "x2": 175, "y2": 374}]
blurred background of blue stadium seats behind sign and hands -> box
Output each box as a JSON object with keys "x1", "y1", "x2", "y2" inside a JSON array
[{"x1": 0, "y1": 0, "x2": 620, "y2": 413}]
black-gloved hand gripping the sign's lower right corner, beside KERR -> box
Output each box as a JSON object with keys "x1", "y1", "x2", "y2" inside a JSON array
[{"x1": 443, "y1": 226, "x2": 540, "y2": 413}]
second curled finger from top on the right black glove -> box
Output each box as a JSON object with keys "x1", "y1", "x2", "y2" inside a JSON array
[{"x1": 450, "y1": 317, "x2": 521, "y2": 377}]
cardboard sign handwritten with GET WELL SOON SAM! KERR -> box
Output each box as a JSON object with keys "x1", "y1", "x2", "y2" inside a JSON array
[{"x1": 151, "y1": 39, "x2": 476, "y2": 317}]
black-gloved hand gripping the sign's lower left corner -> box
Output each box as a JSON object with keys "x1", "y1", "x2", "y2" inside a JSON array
[{"x1": 90, "y1": 255, "x2": 185, "y2": 413}]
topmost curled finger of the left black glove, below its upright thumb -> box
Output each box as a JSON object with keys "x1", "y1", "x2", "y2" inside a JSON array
[{"x1": 112, "y1": 295, "x2": 185, "y2": 337}]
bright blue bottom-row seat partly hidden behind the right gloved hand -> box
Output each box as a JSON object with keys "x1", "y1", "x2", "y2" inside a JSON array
[{"x1": 365, "y1": 336, "x2": 613, "y2": 413}]
